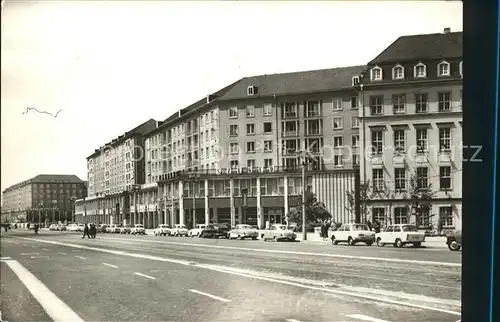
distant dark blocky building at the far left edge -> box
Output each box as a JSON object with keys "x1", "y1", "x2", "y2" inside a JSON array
[{"x1": 2, "y1": 174, "x2": 87, "y2": 222}]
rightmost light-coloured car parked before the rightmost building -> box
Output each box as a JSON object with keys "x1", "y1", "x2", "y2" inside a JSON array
[{"x1": 375, "y1": 224, "x2": 425, "y2": 248}]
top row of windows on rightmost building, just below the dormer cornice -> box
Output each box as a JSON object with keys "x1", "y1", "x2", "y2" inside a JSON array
[{"x1": 369, "y1": 90, "x2": 463, "y2": 115}]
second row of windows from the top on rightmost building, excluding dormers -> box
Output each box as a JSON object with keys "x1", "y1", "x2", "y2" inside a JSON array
[{"x1": 371, "y1": 127, "x2": 458, "y2": 155}]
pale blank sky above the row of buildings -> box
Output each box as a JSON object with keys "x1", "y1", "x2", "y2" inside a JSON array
[{"x1": 1, "y1": 0, "x2": 462, "y2": 191}]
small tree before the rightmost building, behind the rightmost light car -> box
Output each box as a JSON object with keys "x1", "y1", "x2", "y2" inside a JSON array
[{"x1": 404, "y1": 172, "x2": 437, "y2": 227}]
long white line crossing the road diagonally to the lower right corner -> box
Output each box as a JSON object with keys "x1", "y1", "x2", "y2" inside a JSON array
[{"x1": 19, "y1": 237, "x2": 461, "y2": 316}]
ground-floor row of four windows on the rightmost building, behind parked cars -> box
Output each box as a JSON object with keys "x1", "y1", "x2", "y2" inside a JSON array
[{"x1": 372, "y1": 206, "x2": 454, "y2": 227}]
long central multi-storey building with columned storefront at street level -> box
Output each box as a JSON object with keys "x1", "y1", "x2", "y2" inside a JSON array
[{"x1": 131, "y1": 66, "x2": 365, "y2": 227}]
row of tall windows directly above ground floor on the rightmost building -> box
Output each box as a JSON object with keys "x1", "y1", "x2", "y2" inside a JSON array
[{"x1": 372, "y1": 166, "x2": 452, "y2": 192}]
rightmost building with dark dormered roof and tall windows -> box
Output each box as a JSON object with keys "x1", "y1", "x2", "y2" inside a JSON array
[{"x1": 357, "y1": 29, "x2": 463, "y2": 229}]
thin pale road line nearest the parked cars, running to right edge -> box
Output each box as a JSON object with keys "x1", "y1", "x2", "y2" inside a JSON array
[{"x1": 103, "y1": 237, "x2": 462, "y2": 267}]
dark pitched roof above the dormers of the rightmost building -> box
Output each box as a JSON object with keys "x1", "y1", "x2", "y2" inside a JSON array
[{"x1": 368, "y1": 31, "x2": 463, "y2": 65}]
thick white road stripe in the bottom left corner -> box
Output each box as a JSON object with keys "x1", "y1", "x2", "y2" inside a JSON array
[{"x1": 0, "y1": 260, "x2": 84, "y2": 322}]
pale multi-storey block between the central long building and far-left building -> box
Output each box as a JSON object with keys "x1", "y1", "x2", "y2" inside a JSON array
[{"x1": 76, "y1": 119, "x2": 158, "y2": 223}]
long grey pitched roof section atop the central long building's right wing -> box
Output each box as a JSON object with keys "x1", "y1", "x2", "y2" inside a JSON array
[{"x1": 220, "y1": 66, "x2": 366, "y2": 101}]
